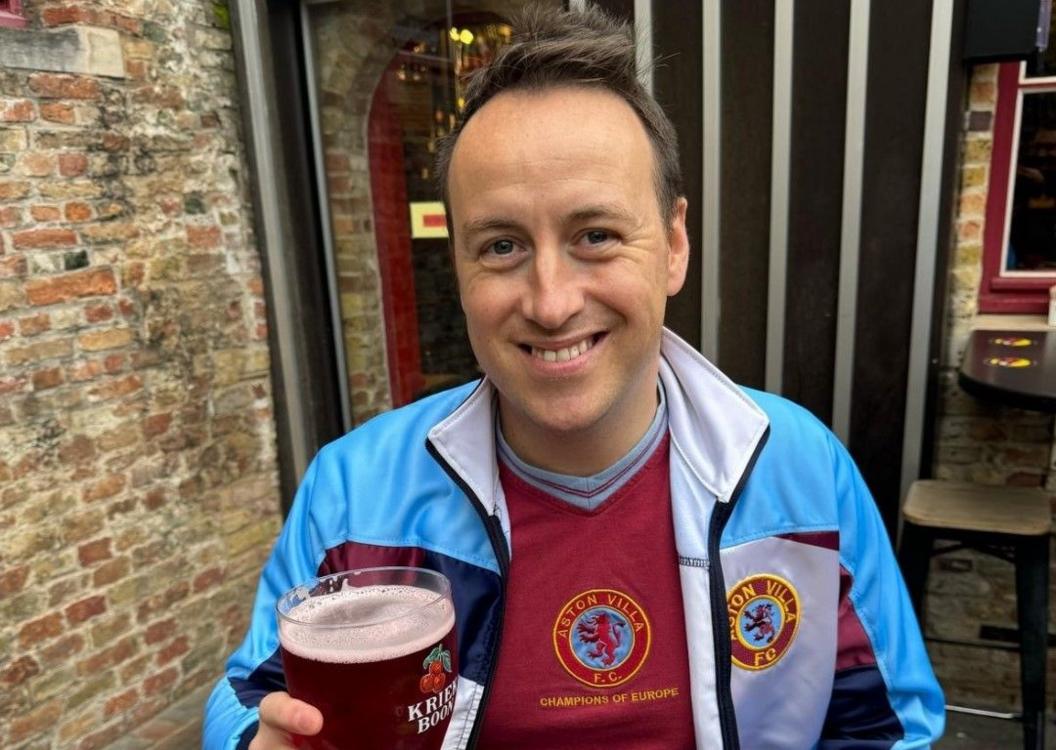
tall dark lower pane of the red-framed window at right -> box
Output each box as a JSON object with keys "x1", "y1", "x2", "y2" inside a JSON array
[{"x1": 1005, "y1": 92, "x2": 1056, "y2": 270}]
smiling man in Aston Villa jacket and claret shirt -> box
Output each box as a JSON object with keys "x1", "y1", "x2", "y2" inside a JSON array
[{"x1": 206, "y1": 5, "x2": 943, "y2": 750}]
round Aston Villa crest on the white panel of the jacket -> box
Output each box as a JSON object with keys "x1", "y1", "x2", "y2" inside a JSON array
[{"x1": 727, "y1": 574, "x2": 799, "y2": 670}]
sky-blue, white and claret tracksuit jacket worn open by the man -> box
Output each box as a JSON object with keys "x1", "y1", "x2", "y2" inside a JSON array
[{"x1": 204, "y1": 331, "x2": 944, "y2": 750}]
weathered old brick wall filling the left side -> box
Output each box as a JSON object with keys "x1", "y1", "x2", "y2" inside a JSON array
[{"x1": 0, "y1": 0, "x2": 279, "y2": 750}]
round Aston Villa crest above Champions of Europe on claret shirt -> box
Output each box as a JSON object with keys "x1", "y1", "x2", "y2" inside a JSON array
[{"x1": 553, "y1": 588, "x2": 653, "y2": 688}]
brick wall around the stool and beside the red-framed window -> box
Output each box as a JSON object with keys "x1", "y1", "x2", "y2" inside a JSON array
[{"x1": 927, "y1": 65, "x2": 1056, "y2": 709}]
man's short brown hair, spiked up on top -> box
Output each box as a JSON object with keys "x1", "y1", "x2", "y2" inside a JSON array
[{"x1": 436, "y1": 5, "x2": 682, "y2": 231}]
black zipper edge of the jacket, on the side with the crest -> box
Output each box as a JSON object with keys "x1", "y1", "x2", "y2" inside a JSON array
[{"x1": 708, "y1": 426, "x2": 770, "y2": 750}]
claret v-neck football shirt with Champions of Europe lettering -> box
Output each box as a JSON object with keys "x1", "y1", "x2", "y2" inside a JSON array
[{"x1": 480, "y1": 404, "x2": 694, "y2": 750}]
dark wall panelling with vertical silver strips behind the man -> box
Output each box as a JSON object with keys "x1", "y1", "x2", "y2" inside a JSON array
[{"x1": 616, "y1": 0, "x2": 965, "y2": 532}]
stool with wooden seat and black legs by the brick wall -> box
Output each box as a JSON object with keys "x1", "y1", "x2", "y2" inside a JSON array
[{"x1": 899, "y1": 480, "x2": 1052, "y2": 750}]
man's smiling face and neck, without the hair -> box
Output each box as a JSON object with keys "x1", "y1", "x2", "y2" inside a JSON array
[{"x1": 449, "y1": 87, "x2": 689, "y2": 470}]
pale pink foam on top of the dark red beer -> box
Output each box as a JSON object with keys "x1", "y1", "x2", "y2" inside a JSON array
[{"x1": 279, "y1": 586, "x2": 455, "y2": 663}]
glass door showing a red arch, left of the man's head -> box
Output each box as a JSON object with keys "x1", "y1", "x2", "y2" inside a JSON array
[{"x1": 302, "y1": 0, "x2": 562, "y2": 427}]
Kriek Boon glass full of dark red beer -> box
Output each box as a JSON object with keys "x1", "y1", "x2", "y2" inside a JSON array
[{"x1": 276, "y1": 567, "x2": 458, "y2": 750}]
